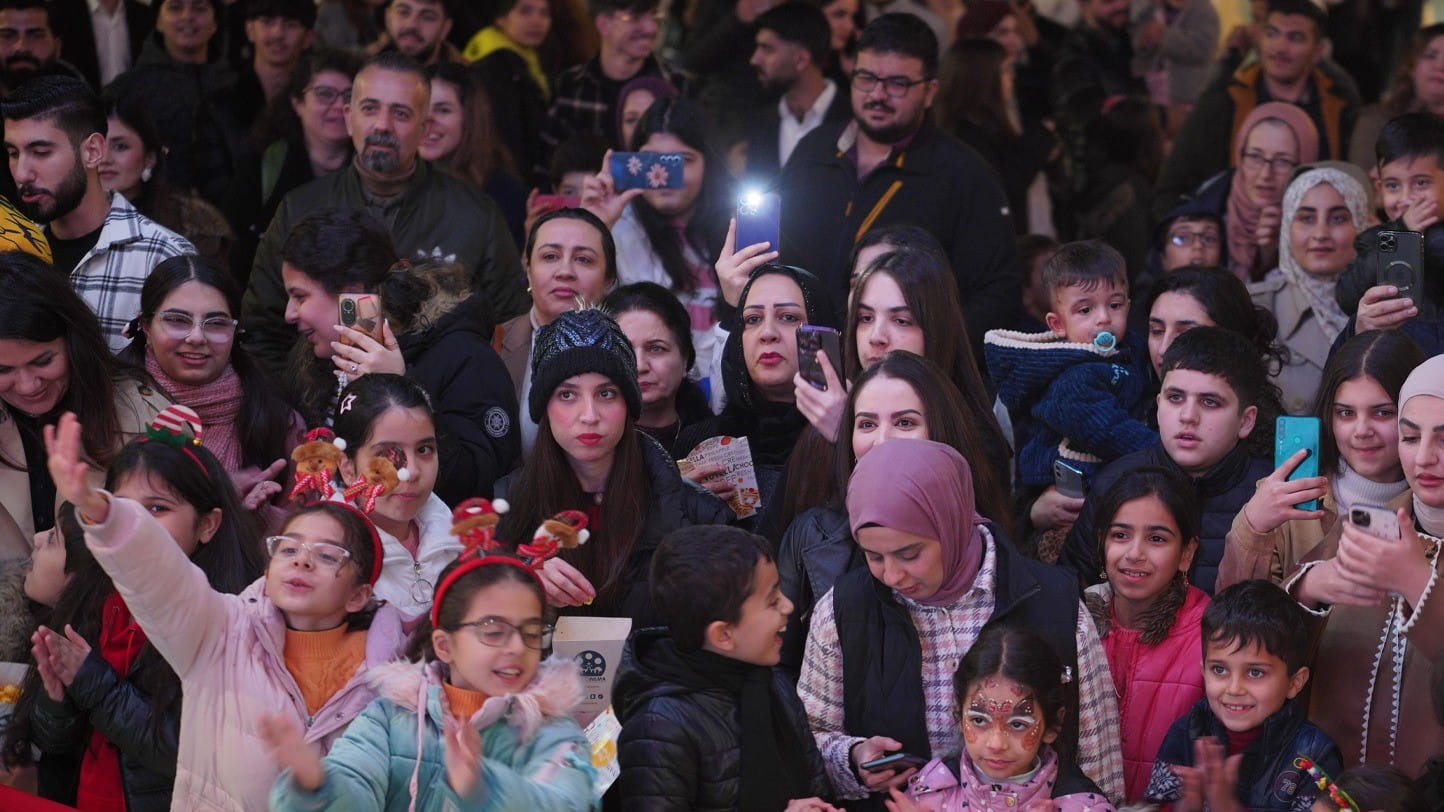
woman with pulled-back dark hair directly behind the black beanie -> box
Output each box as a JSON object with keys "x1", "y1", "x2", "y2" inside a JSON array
[{"x1": 495, "y1": 208, "x2": 617, "y2": 454}]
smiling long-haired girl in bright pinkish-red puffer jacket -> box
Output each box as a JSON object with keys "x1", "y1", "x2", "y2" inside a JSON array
[{"x1": 1084, "y1": 468, "x2": 1209, "y2": 800}]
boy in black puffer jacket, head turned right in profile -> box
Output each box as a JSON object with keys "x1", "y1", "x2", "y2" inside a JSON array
[{"x1": 612, "y1": 524, "x2": 835, "y2": 812}]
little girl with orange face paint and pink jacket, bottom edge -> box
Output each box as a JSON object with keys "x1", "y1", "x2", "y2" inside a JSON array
[{"x1": 887, "y1": 624, "x2": 1113, "y2": 812}]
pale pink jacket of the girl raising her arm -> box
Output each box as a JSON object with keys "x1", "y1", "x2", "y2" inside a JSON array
[{"x1": 85, "y1": 497, "x2": 406, "y2": 812}]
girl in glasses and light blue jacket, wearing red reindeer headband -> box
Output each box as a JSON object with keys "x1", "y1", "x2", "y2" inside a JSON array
[{"x1": 267, "y1": 549, "x2": 593, "y2": 812}]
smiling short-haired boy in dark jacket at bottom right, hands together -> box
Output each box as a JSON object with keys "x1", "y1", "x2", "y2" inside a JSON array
[{"x1": 1145, "y1": 581, "x2": 1343, "y2": 812}]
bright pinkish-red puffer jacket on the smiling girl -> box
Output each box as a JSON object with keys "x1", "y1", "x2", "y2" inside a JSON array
[{"x1": 1089, "y1": 584, "x2": 1209, "y2": 803}]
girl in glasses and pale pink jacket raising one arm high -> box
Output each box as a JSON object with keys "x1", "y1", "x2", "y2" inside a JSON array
[{"x1": 45, "y1": 413, "x2": 404, "y2": 812}]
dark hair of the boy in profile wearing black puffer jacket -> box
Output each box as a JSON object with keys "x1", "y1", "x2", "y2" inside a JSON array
[{"x1": 651, "y1": 524, "x2": 773, "y2": 652}]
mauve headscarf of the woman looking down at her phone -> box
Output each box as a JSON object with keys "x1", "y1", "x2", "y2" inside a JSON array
[{"x1": 848, "y1": 439, "x2": 986, "y2": 607}]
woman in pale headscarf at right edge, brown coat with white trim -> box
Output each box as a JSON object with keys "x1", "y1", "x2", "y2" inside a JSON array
[{"x1": 1284, "y1": 355, "x2": 1444, "y2": 776}]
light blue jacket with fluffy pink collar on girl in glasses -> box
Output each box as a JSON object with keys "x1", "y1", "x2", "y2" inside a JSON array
[{"x1": 271, "y1": 659, "x2": 595, "y2": 812}]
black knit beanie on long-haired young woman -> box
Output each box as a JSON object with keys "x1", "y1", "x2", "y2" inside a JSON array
[{"x1": 527, "y1": 308, "x2": 641, "y2": 423}]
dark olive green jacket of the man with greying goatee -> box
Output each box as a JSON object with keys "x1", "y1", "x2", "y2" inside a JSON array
[{"x1": 241, "y1": 159, "x2": 531, "y2": 373}]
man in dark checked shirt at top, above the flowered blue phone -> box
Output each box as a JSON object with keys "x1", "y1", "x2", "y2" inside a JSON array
[{"x1": 537, "y1": 0, "x2": 686, "y2": 161}]
